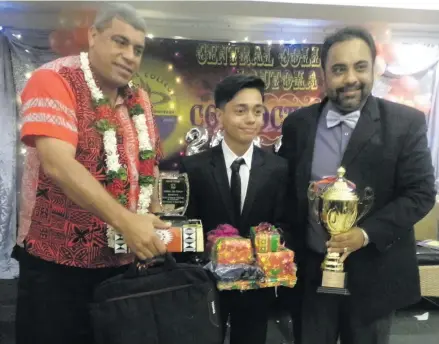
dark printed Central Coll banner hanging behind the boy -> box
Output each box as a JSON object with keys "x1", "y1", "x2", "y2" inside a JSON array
[{"x1": 129, "y1": 39, "x2": 323, "y2": 169}]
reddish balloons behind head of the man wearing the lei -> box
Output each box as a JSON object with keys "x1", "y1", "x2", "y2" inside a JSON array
[{"x1": 49, "y1": 10, "x2": 96, "y2": 56}]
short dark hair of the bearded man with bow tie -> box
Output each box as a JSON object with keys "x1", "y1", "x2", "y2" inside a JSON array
[{"x1": 320, "y1": 26, "x2": 377, "y2": 70}]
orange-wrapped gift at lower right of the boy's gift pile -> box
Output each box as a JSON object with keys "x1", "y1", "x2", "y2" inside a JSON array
[{"x1": 256, "y1": 249, "x2": 296, "y2": 279}]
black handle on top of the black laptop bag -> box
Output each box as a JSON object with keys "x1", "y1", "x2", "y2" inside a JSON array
[{"x1": 125, "y1": 252, "x2": 178, "y2": 278}]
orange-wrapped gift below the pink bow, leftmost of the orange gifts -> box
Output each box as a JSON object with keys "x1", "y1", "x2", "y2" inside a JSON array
[{"x1": 212, "y1": 237, "x2": 254, "y2": 265}]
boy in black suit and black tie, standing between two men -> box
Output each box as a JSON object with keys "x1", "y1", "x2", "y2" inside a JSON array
[{"x1": 181, "y1": 75, "x2": 287, "y2": 344}]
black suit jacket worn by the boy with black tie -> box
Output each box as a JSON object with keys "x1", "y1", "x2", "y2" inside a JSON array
[{"x1": 180, "y1": 145, "x2": 287, "y2": 236}]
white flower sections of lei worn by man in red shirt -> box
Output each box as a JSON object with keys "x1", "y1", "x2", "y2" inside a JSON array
[{"x1": 80, "y1": 52, "x2": 154, "y2": 253}]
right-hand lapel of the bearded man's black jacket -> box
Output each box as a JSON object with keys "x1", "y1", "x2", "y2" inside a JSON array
[{"x1": 342, "y1": 96, "x2": 380, "y2": 169}]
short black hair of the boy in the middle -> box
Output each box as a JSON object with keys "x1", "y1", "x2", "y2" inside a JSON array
[{"x1": 214, "y1": 74, "x2": 265, "y2": 108}]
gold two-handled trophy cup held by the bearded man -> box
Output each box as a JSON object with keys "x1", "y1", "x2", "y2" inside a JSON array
[{"x1": 308, "y1": 167, "x2": 374, "y2": 295}]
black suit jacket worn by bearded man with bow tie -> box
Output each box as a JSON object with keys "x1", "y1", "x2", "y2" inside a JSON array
[{"x1": 279, "y1": 96, "x2": 436, "y2": 319}]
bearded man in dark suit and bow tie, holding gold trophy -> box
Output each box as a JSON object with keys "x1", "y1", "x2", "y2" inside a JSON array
[{"x1": 279, "y1": 28, "x2": 435, "y2": 344}]
